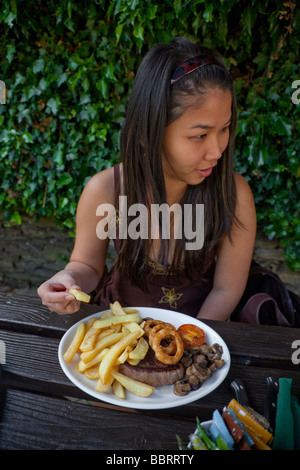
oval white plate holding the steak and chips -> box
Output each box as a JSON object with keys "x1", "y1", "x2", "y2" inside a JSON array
[{"x1": 58, "y1": 307, "x2": 231, "y2": 410}]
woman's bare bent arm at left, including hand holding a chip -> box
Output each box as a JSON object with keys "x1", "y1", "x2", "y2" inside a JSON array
[{"x1": 38, "y1": 168, "x2": 114, "y2": 314}]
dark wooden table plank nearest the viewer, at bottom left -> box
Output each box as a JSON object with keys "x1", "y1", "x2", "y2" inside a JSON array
[{"x1": 0, "y1": 390, "x2": 195, "y2": 451}]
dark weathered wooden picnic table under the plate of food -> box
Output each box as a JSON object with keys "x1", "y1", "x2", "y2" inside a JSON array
[{"x1": 0, "y1": 294, "x2": 300, "y2": 451}]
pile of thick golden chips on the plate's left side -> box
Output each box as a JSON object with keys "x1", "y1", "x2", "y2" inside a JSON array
[{"x1": 63, "y1": 302, "x2": 154, "y2": 399}]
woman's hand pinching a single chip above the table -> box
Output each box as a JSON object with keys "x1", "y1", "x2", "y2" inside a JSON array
[{"x1": 37, "y1": 270, "x2": 80, "y2": 315}]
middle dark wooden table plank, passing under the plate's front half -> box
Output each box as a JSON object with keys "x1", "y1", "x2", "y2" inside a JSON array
[{"x1": 0, "y1": 331, "x2": 300, "y2": 420}]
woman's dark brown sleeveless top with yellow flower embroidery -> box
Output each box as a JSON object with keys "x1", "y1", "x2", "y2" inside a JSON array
[{"x1": 94, "y1": 165, "x2": 214, "y2": 317}]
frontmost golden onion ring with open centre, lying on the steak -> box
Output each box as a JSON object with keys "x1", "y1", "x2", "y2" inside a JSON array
[{"x1": 151, "y1": 328, "x2": 184, "y2": 365}]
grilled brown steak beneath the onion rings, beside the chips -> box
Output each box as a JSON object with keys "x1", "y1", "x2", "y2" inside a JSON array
[{"x1": 119, "y1": 348, "x2": 185, "y2": 387}]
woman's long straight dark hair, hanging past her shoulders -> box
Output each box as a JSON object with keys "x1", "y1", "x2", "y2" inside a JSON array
[{"x1": 119, "y1": 38, "x2": 237, "y2": 287}]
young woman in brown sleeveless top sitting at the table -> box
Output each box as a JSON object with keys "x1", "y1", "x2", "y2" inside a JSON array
[{"x1": 38, "y1": 38, "x2": 256, "y2": 320}]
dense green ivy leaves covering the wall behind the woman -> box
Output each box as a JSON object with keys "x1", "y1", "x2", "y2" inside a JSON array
[{"x1": 0, "y1": 0, "x2": 300, "y2": 269}]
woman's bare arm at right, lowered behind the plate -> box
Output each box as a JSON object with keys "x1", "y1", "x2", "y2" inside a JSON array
[{"x1": 197, "y1": 174, "x2": 256, "y2": 320}]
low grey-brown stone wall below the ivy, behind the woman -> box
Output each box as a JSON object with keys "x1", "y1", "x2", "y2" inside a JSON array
[{"x1": 0, "y1": 216, "x2": 300, "y2": 296}]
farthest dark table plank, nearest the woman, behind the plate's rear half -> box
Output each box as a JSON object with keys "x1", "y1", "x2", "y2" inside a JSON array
[{"x1": 0, "y1": 294, "x2": 300, "y2": 370}]
